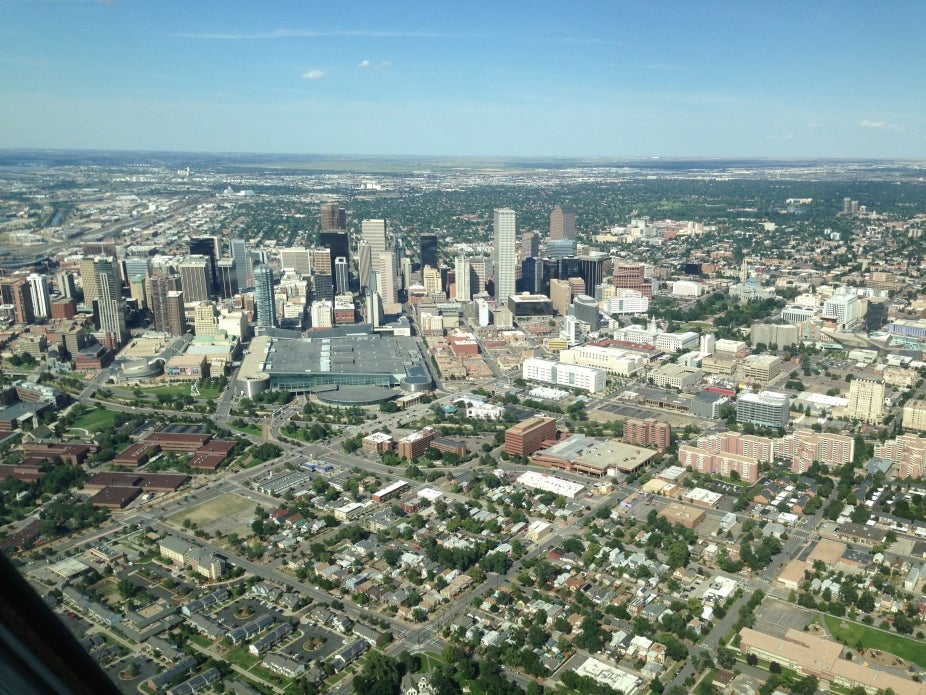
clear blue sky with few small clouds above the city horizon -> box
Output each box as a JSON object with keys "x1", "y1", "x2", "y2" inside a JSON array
[{"x1": 0, "y1": 0, "x2": 926, "y2": 158}]
